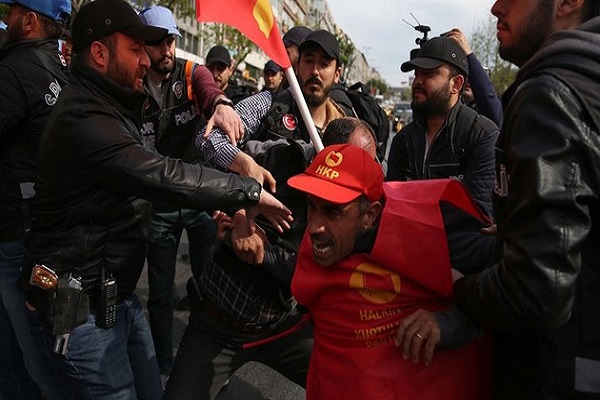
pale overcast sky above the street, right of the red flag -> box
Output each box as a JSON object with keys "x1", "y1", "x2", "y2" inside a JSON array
[{"x1": 328, "y1": 0, "x2": 493, "y2": 86}]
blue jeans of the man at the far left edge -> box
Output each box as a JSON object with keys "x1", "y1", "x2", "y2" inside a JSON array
[{"x1": 0, "y1": 239, "x2": 64, "y2": 400}]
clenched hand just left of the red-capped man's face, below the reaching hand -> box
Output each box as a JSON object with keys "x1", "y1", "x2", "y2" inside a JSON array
[{"x1": 231, "y1": 210, "x2": 265, "y2": 265}]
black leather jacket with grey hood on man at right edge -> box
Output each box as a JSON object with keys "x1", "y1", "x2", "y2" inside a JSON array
[{"x1": 455, "y1": 17, "x2": 600, "y2": 400}]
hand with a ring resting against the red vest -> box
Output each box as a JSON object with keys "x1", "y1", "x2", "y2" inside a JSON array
[{"x1": 394, "y1": 309, "x2": 441, "y2": 365}]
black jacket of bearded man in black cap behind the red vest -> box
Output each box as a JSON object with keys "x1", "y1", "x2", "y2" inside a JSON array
[{"x1": 386, "y1": 101, "x2": 499, "y2": 216}]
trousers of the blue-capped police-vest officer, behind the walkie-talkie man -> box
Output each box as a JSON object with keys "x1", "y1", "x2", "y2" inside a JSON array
[{"x1": 147, "y1": 210, "x2": 216, "y2": 375}]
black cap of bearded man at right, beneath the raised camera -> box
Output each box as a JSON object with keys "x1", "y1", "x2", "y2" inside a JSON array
[{"x1": 400, "y1": 36, "x2": 469, "y2": 77}]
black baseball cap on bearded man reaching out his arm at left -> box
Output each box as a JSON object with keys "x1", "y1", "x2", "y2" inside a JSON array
[{"x1": 72, "y1": 0, "x2": 167, "y2": 53}]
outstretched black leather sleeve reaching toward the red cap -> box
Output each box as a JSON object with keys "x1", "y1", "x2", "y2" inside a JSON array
[{"x1": 65, "y1": 108, "x2": 261, "y2": 209}]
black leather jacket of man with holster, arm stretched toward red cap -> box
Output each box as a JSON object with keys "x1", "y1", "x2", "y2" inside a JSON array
[{"x1": 21, "y1": 59, "x2": 261, "y2": 304}]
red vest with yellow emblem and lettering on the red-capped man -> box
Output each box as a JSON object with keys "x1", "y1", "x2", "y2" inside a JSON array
[{"x1": 292, "y1": 180, "x2": 492, "y2": 400}]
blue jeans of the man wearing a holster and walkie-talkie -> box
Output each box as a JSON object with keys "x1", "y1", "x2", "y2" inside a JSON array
[{"x1": 42, "y1": 294, "x2": 162, "y2": 400}]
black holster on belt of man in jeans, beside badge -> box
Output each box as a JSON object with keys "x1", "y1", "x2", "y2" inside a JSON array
[{"x1": 35, "y1": 274, "x2": 90, "y2": 335}]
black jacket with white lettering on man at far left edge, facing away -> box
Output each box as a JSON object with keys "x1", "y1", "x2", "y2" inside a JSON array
[{"x1": 0, "y1": 39, "x2": 67, "y2": 234}]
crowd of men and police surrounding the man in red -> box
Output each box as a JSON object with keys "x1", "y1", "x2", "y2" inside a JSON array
[{"x1": 0, "y1": 0, "x2": 600, "y2": 400}]
